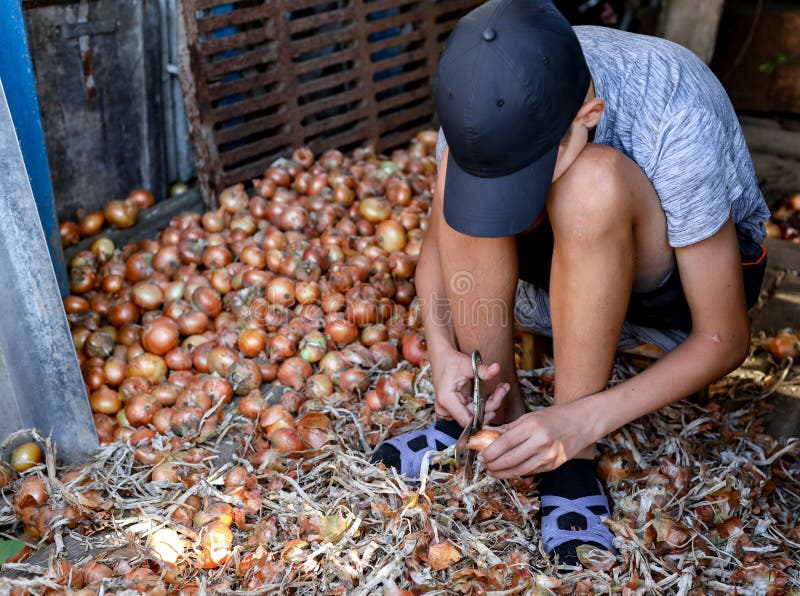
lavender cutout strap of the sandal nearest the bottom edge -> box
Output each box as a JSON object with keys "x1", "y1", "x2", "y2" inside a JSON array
[{"x1": 541, "y1": 495, "x2": 614, "y2": 553}]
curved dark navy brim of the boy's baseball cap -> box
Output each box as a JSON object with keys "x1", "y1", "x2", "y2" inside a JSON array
[{"x1": 444, "y1": 146, "x2": 558, "y2": 238}]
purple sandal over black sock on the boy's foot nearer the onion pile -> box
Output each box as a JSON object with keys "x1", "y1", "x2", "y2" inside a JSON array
[{"x1": 370, "y1": 420, "x2": 463, "y2": 479}]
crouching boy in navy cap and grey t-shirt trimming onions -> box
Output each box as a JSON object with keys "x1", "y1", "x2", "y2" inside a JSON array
[{"x1": 373, "y1": 0, "x2": 769, "y2": 564}]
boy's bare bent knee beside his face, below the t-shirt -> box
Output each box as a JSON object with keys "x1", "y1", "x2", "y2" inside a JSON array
[{"x1": 547, "y1": 144, "x2": 652, "y2": 242}]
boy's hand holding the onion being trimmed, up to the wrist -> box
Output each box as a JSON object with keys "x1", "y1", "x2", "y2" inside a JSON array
[{"x1": 478, "y1": 402, "x2": 595, "y2": 478}]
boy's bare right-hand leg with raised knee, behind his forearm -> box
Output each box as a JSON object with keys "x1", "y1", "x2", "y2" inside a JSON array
[{"x1": 548, "y1": 145, "x2": 673, "y2": 458}]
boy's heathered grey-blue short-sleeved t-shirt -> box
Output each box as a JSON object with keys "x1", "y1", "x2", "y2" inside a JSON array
[{"x1": 437, "y1": 27, "x2": 770, "y2": 248}]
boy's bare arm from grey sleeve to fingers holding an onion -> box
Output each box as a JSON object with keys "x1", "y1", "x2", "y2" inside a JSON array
[{"x1": 481, "y1": 221, "x2": 750, "y2": 478}]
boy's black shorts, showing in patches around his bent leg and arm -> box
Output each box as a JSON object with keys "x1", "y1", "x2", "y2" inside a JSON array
[{"x1": 517, "y1": 219, "x2": 767, "y2": 331}]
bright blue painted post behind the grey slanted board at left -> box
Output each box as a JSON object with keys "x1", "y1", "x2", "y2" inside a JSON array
[{"x1": 0, "y1": 0, "x2": 69, "y2": 296}]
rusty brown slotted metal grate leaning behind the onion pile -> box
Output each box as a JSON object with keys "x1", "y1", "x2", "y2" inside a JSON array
[{"x1": 179, "y1": 0, "x2": 481, "y2": 200}]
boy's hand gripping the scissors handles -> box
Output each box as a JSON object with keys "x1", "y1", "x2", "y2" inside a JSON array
[{"x1": 429, "y1": 349, "x2": 509, "y2": 426}]
